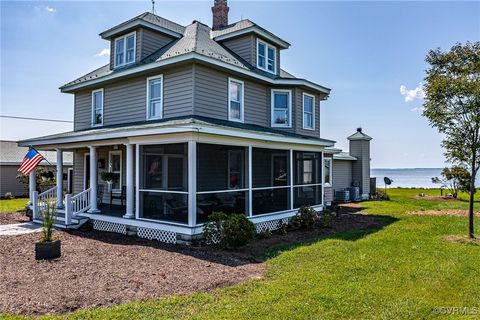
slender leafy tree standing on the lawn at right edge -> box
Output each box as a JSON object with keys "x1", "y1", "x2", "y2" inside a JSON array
[{"x1": 423, "y1": 42, "x2": 480, "y2": 238}]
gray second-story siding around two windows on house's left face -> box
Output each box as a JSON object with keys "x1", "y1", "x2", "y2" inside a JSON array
[{"x1": 74, "y1": 66, "x2": 193, "y2": 130}]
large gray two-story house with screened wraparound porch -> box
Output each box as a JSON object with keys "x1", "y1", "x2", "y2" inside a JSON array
[{"x1": 19, "y1": 0, "x2": 369, "y2": 242}]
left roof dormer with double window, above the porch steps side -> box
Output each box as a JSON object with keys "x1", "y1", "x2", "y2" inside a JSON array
[{"x1": 100, "y1": 12, "x2": 185, "y2": 70}]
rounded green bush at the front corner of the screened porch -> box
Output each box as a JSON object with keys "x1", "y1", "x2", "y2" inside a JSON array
[{"x1": 203, "y1": 212, "x2": 255, "y2": 248}]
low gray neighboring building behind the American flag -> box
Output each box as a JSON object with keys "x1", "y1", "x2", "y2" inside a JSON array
[{"x1": 0, "y1": 140, "x2": 73, "y2": 198}]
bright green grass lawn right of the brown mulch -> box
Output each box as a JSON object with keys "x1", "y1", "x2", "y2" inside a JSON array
[{"x1": 0, "y1": 189, "x2": 480, "y2": 320}]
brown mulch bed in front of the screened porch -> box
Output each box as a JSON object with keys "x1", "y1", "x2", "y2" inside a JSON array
[{"x1": 0, "y1": 215, "x2": 380, "y2": 315}]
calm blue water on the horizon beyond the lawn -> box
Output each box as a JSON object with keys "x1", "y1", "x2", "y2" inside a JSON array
[{"x1": 371, "y1": 168, "x2": 442, "y2": 188}]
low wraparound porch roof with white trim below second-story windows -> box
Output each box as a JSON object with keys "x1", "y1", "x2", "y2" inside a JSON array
[{"x1": 18, "y1": 116, "x2": 335, "y2": 148}]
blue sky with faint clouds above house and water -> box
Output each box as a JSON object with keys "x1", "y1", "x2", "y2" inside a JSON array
[{"x1": 0, "y1": 0, "x2": 480, "y2": 168}]
